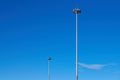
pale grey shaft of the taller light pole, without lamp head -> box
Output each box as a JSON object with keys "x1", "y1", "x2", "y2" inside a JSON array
[{"x1": 76, "y1": 13, "x2": 78, "y2": 80}]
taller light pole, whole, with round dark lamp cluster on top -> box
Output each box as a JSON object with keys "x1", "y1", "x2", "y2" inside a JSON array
[{"x1": 73, "y1": 8, "x2": 81, "y2": 80}]
